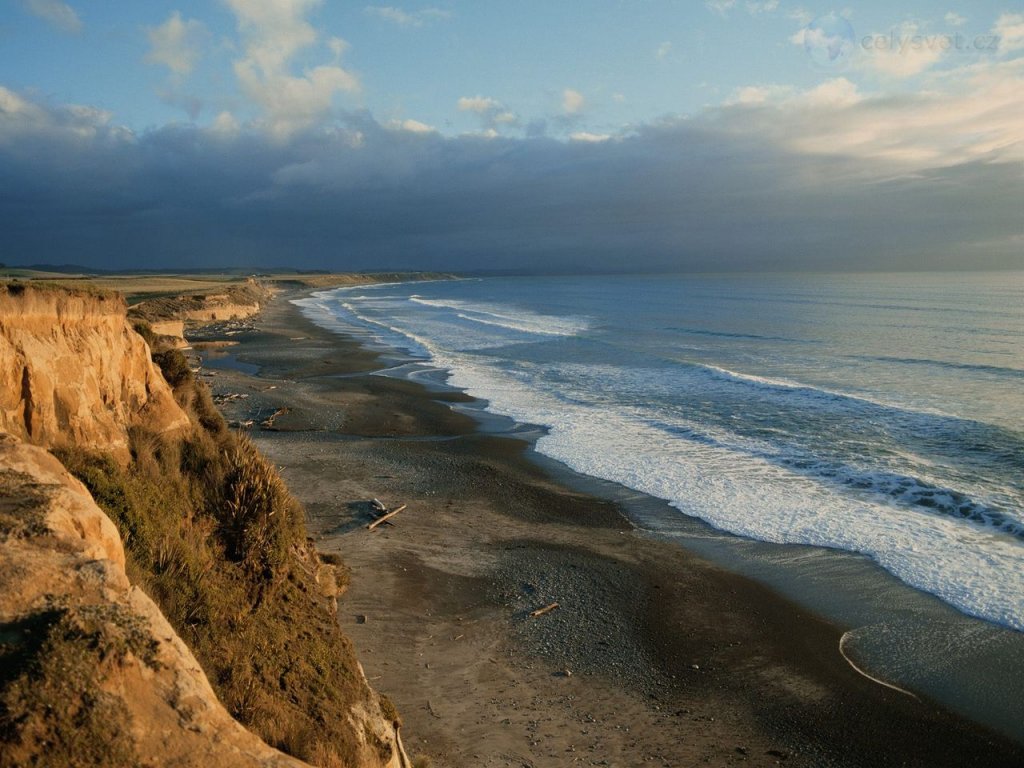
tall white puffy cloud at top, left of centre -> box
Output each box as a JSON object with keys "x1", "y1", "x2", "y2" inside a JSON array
[{"x1": 225, "y1": 0, "x2": 359, "y2": 139}]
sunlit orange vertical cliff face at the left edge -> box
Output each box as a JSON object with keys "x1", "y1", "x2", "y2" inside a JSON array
[{"x1": 0, "y1": 286, "x2": 188, "y2": 461}]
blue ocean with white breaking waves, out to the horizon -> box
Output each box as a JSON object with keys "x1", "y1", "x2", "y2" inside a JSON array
[{"x1": 296, "y1": 272, "x2": 1024, "y2": 630}]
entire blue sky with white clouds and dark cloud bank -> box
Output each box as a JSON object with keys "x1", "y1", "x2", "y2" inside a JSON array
[{"x1": 0, "y1": 0, "x2": 1024, "y2": 271}]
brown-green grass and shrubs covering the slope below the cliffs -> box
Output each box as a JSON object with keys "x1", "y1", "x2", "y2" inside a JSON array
[{"x1": 59, "y1": 350, "x2": 389, "y2": 766}]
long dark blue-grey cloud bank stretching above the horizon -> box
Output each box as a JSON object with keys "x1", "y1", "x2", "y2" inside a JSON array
[{"x1": 0, "y1": 97, "x2": 1024, "y2": 271}]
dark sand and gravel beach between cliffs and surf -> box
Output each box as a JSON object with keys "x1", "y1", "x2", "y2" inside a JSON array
[{"x1": 199, "y1": 297, "x2": 1024, "y2": 766}]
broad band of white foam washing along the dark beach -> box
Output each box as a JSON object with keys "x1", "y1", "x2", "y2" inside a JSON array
[{"x1": 435, "y1": 355, "x2": 1024, "y2": 630}]
